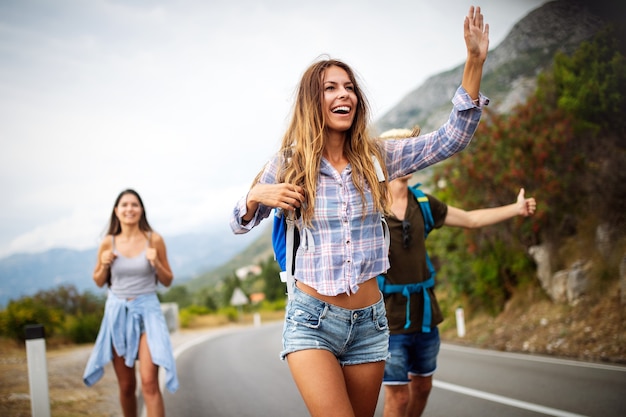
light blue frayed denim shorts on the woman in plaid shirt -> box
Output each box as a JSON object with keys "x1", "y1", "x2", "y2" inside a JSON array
[{"x1": 280, "y1": 287, "x2": 389, "y2": 366}]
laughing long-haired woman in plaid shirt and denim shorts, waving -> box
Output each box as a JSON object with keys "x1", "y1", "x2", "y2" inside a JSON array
[{"x1": 231, "y1": 7, "x2": 489, "y2": 417}]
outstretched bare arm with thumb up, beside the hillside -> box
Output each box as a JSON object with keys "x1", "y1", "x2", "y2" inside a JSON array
[{"x1": 443, "y1": 188, "x2": 537, "y2": 229}]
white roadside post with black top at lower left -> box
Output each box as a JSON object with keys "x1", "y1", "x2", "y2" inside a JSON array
[{"x1": 24, "y1": 324, "x2": 50, "y2": 417}]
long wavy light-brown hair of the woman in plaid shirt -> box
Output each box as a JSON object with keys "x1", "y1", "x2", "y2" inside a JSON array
[{"x1": 264, "y1": 59, "x2": 389, "y2": 226}]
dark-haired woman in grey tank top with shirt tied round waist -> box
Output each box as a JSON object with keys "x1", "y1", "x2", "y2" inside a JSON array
[{"x1": 83, "y1": 189, "x2": 178, "y2": 417}]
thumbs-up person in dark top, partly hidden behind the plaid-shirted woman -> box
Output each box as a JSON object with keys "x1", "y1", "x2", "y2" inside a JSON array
[{"x1": 379, "y1": 130, "x2": 536, "y2": 417}]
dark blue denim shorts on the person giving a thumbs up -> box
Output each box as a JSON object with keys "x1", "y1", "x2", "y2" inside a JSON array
[{"x1": 383, "y1": 327, "x2": 440, "y2": 385}]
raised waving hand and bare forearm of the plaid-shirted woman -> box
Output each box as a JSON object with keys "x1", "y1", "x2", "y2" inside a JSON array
[{"x1": 461, "y1": 6, "x2": 489, "y2": 100}]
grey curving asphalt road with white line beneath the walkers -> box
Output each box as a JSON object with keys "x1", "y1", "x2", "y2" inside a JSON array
[{"x1": 164, "y1": 323, "x2": 626, "y2": 417}]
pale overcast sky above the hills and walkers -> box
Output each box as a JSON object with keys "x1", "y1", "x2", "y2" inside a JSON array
[{"x1": 0, "y1": 0, "x2": 546, "y2": 257}]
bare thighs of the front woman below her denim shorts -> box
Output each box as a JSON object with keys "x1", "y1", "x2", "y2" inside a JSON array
[{"x1": 287, "y1": 349, "x2": 385, "y2": 417}]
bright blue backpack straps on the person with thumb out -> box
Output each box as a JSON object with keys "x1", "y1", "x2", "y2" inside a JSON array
[{"x1": 376, "y1": 183, "x2": 435, "y2": 333}]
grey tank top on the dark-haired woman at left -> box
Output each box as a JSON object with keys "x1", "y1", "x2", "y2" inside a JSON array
[{"x1": 111, "y1": 232, "x2": 157, "y2": 298}]
